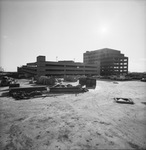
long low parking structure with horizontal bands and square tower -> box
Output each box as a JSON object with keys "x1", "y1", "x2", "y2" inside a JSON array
[{"x1": 18, "y1": 56, "x2": 100, "y2": 76}]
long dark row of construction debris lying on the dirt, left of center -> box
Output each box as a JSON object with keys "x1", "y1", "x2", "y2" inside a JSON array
[{"x1": 9, "y1": 83, "x2": 88, "y2": 100}]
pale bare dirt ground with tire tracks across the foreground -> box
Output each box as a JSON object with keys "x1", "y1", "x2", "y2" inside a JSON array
[{"x1": 0, "y1": 80, "x2": 146, "y2": 150}]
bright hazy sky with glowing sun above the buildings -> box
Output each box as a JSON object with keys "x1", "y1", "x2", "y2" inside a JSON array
[{"x1": 0, "y1": 0, "x2": 146, "y2": 71}]
